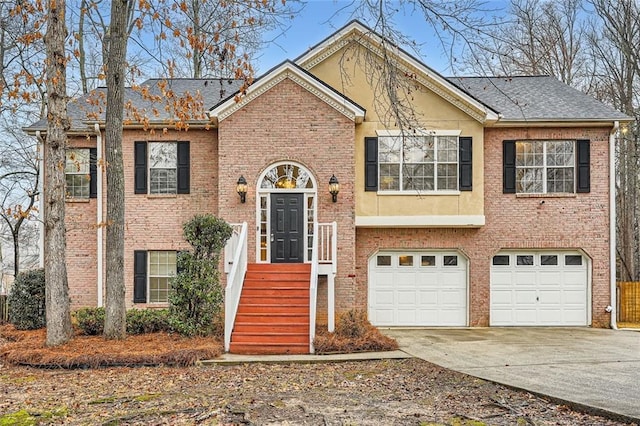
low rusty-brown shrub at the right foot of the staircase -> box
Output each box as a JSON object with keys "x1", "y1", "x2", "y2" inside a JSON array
[{"x1": 313, "y1": 310, "x2": 398, "y2": 354}]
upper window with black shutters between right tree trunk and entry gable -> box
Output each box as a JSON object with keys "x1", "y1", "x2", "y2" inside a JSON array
[{"x1": 134, "y1": 142, "x2": 190, "y2": 195}]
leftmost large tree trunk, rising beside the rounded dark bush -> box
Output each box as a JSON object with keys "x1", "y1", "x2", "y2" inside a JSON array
[{"x1": 44, "y1": 0, "x2": 72, "y2": 346}]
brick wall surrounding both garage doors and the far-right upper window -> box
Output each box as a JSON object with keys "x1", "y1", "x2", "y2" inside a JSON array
[{"x1": 356, "y1": 128, "x2": 611, "y2": 327}]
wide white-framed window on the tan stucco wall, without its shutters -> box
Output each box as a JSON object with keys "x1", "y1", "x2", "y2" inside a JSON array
[{"x1": 377, "y1": 135, "x2": 462, "y2": 191}]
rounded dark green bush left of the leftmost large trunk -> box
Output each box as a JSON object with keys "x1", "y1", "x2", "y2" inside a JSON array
[{"x1": 7, "y1": 269, "x2": 47, "y2": 330}]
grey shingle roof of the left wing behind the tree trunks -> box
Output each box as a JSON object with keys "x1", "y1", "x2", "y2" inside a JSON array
[{"x1": 25, "y1": 79, "x2": 242, "y2": 132}]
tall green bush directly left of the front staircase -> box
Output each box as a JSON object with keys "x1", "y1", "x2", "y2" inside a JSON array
[{"x1": 169, "y1": 215, "x2": 233, "y2": 336}]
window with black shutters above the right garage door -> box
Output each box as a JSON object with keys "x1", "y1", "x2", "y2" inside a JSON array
[{"x1": 503, "y1": 140, "x2": 590, "y2": 194}]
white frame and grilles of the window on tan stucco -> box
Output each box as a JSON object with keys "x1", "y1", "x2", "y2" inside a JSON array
[{"x1": 376, "y1": 130, "x2": 462, "y2": 195}]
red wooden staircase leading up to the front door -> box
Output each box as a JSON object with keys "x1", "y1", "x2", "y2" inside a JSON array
[{"x1": 229, "y1": 263, "x2": 311, "y2": 354}]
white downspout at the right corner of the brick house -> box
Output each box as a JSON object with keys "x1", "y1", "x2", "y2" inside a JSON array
[{"x1": 609, "y1": 121, "x2": 620, "y2": 330}]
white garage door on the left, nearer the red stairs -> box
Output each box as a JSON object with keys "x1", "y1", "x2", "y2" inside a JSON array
[{"x1": 369, "y1": 251, "x2": 467, "y2": 326}]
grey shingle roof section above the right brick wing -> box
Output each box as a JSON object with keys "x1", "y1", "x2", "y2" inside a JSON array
[{"x1": 448, "y1": 76, "x2": 632, "y2": 121}]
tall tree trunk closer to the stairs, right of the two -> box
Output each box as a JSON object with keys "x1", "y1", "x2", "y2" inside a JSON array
[{"x1": 104, "y1": 0, "x2": 128, "y2": 339}]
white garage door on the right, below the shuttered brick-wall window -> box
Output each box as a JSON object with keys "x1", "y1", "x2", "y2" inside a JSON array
[{"x1": 490, "y1": 251, "x2": 588, "y2": 326}]
